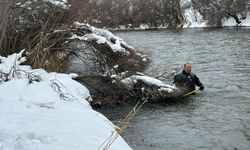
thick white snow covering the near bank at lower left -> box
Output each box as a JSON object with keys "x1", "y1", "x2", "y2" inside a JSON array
[{"x1": 0, "y1": 51, "x2": 131, "y2": 150}]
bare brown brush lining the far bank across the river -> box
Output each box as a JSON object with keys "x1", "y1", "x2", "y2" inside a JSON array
[{"x1": 70, "y1": 0, "x2": 250, "y2": 29}]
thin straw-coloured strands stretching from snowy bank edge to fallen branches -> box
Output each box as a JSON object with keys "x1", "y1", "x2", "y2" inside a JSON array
[{"x1": 98, "y1": 100, "x2": 147, "y2": 150}]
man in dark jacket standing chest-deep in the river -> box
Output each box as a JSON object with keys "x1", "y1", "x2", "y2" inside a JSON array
[{"x1": 174, "y1": 63, "x2": 204, "y2": 93}]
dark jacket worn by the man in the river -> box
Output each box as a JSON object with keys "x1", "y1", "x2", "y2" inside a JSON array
[{"x1": 174, "y1": 70, "x2": 204, "y2": 91}]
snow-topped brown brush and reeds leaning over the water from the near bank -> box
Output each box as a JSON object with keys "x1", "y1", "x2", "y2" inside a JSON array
[{"x1": 0, "y1": 0, "x2": 179, "y2": 106}]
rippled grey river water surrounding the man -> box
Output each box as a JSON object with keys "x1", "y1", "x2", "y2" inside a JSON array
[{"x1": 98, "y1": 28, "x2": 250, "y2": 150}]
